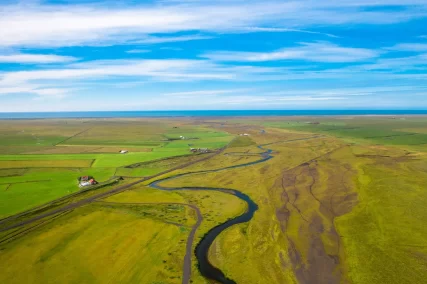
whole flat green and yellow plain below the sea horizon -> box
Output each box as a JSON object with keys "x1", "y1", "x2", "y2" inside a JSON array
[{"x1": 0, "y1": 116, "x2": 427, "y2": 284}]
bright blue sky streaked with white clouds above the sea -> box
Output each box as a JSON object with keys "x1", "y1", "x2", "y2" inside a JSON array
[{"x1": 0, "y1": 0, "x2": 427, "y2": 112}]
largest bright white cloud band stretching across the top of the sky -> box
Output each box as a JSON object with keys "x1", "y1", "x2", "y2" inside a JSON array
[{"x1": 0, "y1": 0, "x2": 427, "y2": 46}]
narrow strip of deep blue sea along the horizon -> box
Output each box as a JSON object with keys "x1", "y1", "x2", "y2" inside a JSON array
[{"x1": 0, "y1": 110, "x2": 427, "y2": 119}]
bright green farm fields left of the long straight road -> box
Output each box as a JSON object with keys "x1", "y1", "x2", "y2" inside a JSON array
[{"x1": 0, "y1": 119, "x2": 232, "y2": 218}]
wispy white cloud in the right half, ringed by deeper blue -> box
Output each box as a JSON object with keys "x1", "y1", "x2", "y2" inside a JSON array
[{"x1": 203, "y1": 42, "x2": 379, "y2": 62}]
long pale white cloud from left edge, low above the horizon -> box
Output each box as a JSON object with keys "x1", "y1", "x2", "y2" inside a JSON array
[{"x1": 0, "y1": 59, "x2": 304, "y2": 88}]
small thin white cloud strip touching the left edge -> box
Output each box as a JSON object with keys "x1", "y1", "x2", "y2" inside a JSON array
[{"x1": 0, "y1": 53, "x2": 77, "y2": 64}]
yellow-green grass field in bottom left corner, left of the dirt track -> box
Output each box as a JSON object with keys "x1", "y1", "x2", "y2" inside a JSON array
[{"x1": 0, "y1": 206, "x2": 189, "y2": 283}]
